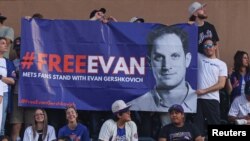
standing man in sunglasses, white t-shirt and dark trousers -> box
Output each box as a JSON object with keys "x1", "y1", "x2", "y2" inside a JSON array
[{"x1": 194, "y1": 38, "x2": 227, "y2": 135}]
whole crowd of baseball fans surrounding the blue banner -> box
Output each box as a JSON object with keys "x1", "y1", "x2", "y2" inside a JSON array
[{"x1": 0, "y1": 2, "x2": 250, "y2": 141}]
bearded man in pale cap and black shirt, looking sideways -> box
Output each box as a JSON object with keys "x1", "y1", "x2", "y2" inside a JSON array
[{"x1": 188, "y1": 2, "x2": 219, "y2": 58}]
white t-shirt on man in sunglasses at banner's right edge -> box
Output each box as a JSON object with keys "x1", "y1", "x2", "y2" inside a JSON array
[{"x1": 197, "y1": 53, "x2": 227, "y2": 101}]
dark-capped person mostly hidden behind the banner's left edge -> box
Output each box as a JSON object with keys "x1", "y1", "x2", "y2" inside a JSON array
[{"x1": 10, "y1": 37, "x2": 34, "y2": 141}]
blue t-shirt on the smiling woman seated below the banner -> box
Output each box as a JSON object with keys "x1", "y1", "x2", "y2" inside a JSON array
[{"x1": 58, "y1": 123, "x2": 89, "y2": 141}]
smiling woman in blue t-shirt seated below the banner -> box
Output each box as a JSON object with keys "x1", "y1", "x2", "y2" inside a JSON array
[{"x1": 58, "y1": 106, "x2": 90, "y2": 141}]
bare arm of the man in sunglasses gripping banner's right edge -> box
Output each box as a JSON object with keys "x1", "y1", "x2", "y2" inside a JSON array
[{"x1": 196, "y1": 76, "x2": 226, "y2": 95}]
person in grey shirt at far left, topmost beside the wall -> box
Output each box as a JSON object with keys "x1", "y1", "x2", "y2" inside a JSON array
[{"x1": 0, "y1": 13, "x2": 14, "y2": 58}]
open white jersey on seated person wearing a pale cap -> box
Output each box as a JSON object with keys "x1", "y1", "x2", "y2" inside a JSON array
[{"x1": 98, "y1": 119, "x2": 138, "y2": 141}]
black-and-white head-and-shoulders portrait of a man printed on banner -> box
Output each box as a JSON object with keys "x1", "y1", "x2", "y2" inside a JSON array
[{"x1": 129, "y1": 25, "x2": 197, "y2": 113}]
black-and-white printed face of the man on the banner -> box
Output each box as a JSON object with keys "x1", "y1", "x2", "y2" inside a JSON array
[{"x1": 151, "y1": 34, "x2": 191, "y2": 89}]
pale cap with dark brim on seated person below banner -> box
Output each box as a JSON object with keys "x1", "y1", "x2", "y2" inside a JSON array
[{"x1": 112, "y1": 100, "x2": 131, "y2": 114}]
